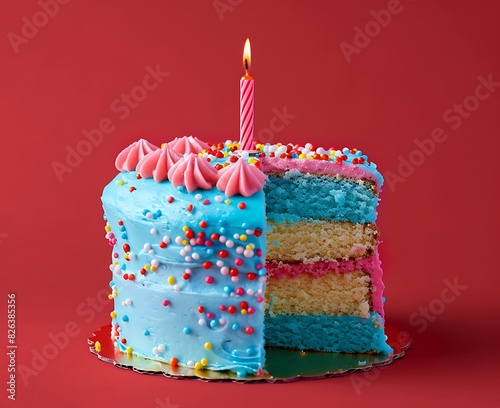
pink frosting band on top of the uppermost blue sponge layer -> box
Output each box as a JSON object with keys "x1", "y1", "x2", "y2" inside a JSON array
[{"x1": 261, "y1": 157, "x2": 381, "y2": 190}]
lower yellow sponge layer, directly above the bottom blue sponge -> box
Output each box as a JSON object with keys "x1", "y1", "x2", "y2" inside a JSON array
[{"x1": 266, "y1": 271, "x2": 371, "y2": 318}]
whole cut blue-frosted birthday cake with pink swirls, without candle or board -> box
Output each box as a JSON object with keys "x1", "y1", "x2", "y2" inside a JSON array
[{"x1": 102, "y1": 136, "x2": 392, "y2": 377}]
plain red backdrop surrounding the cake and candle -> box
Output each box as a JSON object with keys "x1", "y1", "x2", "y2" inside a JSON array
[{"x1": 0, "y1": 0, "x2": 500, "y2": 408}]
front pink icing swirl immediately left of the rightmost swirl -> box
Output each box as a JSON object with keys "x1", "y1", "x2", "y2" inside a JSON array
[{"x1": 168, "y1": 153, "x2": 218, "y2": 193}]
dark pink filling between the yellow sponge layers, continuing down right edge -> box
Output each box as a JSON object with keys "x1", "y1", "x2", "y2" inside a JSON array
[{"x1": 266, "y1": 251, "x2": 384, "y2": 319}]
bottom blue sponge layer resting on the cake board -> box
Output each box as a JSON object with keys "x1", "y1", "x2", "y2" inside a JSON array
[{"x1": 264, "y1": 312, "x2": 393, "y2": 354}]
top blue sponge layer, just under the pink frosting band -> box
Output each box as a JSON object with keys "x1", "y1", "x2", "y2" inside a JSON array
[{"x1": 264, "y1": 171, "x2": 378, "y2": 223}]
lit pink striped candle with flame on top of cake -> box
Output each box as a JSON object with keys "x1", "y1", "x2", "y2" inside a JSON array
[{"x1": 240, "y1": 38, "x2": 254, "y2": 150}]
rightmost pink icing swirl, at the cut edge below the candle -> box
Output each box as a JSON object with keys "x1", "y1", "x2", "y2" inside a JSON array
[{"x1": 217, "y1": 159, "x2": 267, "y2": 197}]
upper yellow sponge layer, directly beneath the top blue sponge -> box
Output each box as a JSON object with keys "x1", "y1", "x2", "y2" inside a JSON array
[{"x1": 266, "y1": 220, "x2": 378, "y2": 263}]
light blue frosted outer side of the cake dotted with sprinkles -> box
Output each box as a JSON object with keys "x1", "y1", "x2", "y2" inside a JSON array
[{"x1": 102, "y1": 171, "x2": 266, "y2": 375}]
